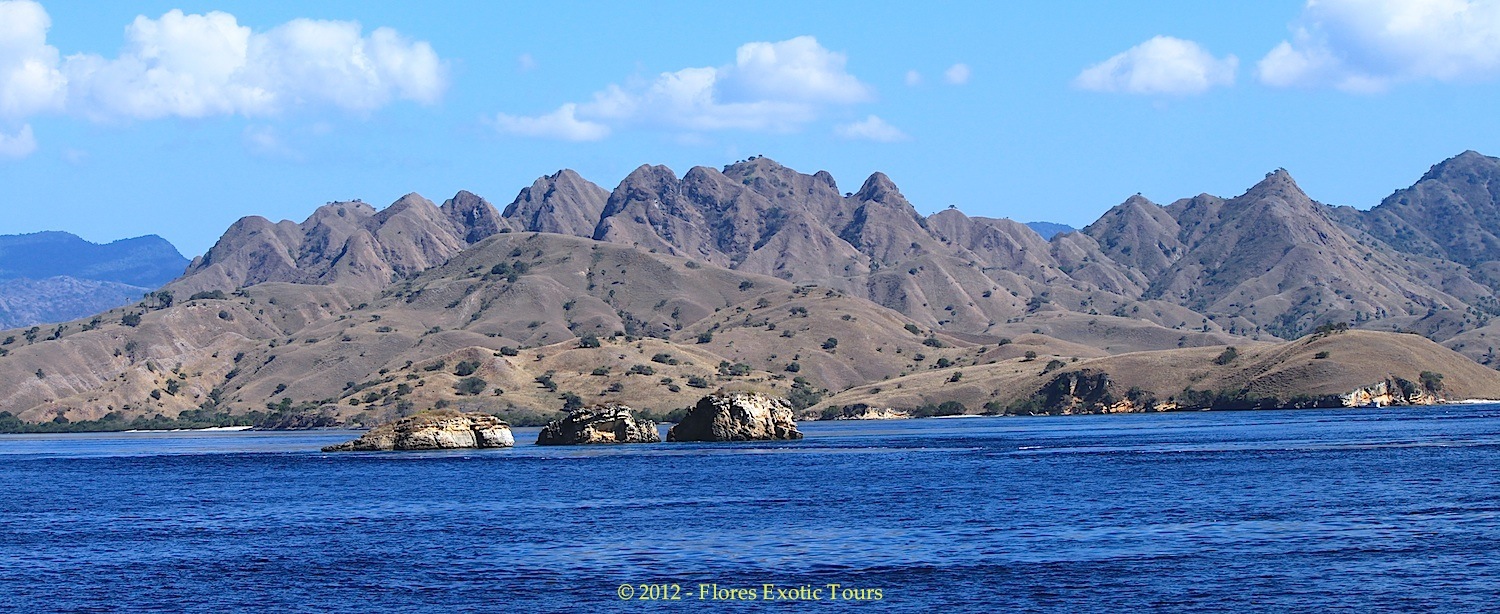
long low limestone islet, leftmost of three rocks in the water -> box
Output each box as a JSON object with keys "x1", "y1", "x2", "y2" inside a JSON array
[{"x1": 323, "y1": 410, "x2": 516, "y2": 452}]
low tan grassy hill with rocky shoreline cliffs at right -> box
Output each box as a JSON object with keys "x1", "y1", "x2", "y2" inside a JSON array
[{"x1": 804, "y1": 330, "x2": 1500, "y2": 417}]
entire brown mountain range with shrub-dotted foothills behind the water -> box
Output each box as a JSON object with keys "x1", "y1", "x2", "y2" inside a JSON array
[{"x1": 0, "y1": 152, "x2": 1500, "y2": 422}]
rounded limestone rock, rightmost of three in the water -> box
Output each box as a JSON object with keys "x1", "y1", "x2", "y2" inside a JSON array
[{"x1": 666, "y1": 392, "x2": 803, "y2": 441}]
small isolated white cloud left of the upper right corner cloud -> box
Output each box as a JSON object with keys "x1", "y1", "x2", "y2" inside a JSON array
[{"x1": 1073, "y1": 36, "x2": 1239, "y2": 95}]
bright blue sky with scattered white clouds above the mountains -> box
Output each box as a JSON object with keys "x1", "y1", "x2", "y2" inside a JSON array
[{"x1": 0, "y1": 0, "x2": 1500, "y2": 257}]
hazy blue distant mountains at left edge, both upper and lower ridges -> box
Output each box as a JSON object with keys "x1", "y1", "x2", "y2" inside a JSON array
[{"x1": 0, "y1": 231, "x2": 188, "y2": 329}]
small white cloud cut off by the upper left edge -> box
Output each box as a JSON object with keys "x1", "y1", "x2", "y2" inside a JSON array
[{"x1": 0, "y1": 0, "x2": 68, "y2": 119}]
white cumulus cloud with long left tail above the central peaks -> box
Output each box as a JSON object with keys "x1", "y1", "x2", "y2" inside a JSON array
[{"x1": 494, "y1": 36, "x2": 873, "y2": 141}]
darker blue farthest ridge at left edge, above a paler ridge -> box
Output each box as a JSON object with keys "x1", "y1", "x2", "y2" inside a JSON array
[{"x1": 0, "y1": 231, "x2": 188, "y2": 288}]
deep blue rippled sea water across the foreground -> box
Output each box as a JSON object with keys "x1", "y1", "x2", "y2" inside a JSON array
[{"x1": 0, "y1": 405, "x2": 1500, "y2": 612}]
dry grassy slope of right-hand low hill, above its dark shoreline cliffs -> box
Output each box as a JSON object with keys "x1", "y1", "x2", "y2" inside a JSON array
[{"x1": 807, "y1": 330, "x2": 1500, "y2": 414}]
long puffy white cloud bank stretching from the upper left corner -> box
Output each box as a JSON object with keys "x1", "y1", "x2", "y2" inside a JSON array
[{"x1": 0, "y1": 0, "x2": 447, "y2": 120}]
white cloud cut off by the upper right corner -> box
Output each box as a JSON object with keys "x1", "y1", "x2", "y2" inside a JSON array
[{"x1": 1257, "y1": 0, "x2": 1500, "y2": 92}]
